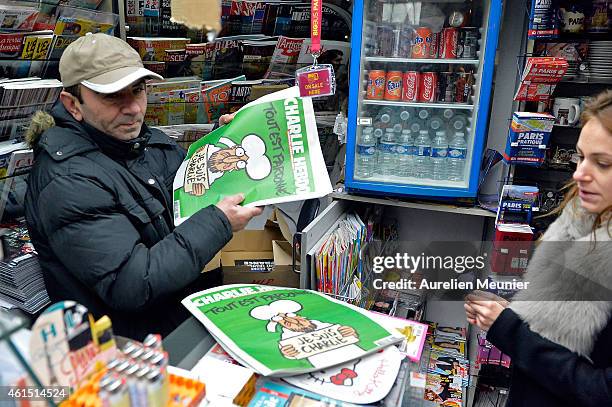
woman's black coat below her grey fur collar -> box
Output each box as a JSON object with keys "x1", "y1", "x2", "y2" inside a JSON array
[{"x1": 487, "y1": 308, "x2": 612, "y2": 407}]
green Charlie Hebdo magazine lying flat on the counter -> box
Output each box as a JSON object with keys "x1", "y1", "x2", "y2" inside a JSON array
[{"x1": 182, "y1": 284, "x2": 404, "y2": 376}]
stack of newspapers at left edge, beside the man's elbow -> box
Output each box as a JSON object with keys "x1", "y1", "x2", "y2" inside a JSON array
[{"x1": 0, "y1": 221, "x2": 50, "y2": 314}]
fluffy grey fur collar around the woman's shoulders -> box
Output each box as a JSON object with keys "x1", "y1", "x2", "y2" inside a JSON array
[{"x1": 510, "y1": 199, "x2": 612, "y2": 358}]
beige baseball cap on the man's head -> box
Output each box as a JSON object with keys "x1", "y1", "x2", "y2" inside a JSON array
[{"x1": 59, "y1": 33, "x2": 163, "y2": 93}]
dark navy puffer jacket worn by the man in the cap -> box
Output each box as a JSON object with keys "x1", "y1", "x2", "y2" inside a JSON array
[{"x1": 26, "y1": 103, "x2": 232, "y2": 339}]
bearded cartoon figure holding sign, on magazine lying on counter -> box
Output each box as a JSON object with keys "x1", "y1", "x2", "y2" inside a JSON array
[{"x1": 250, "y1": 300, "x2": 365, "y2": 367}]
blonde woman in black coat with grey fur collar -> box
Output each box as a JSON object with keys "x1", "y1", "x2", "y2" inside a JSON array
[{"x1": 465, "y1": 91, "x2": 612, "y2": 407}]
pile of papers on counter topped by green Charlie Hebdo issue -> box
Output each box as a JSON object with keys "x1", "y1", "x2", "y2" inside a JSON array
[{"x1": 182, "y1": 284, "x2": 436, "y2": 407}]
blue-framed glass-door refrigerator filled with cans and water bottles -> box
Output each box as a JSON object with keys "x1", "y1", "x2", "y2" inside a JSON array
[{"x1": 346, "y1": 0, "x2": 502, "y2": 198}]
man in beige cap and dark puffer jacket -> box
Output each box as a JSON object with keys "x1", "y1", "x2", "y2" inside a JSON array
[{"x1": 26, "y1": 34, "x2": 261, "y2": 339}]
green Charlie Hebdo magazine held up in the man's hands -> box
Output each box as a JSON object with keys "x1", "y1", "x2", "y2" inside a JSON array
[{"x1": 173, "y1": 87, "x2": 332, "y2": 225}]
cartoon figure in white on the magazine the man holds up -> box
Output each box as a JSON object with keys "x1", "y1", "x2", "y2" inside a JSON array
[{"x1": 183, "y1": 134, "x2": 272, "y2": 196}]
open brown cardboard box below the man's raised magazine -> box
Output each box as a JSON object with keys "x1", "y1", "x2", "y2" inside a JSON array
[{"x1": 204, "y1": 227, "x2": 300, "y2": 288}]
